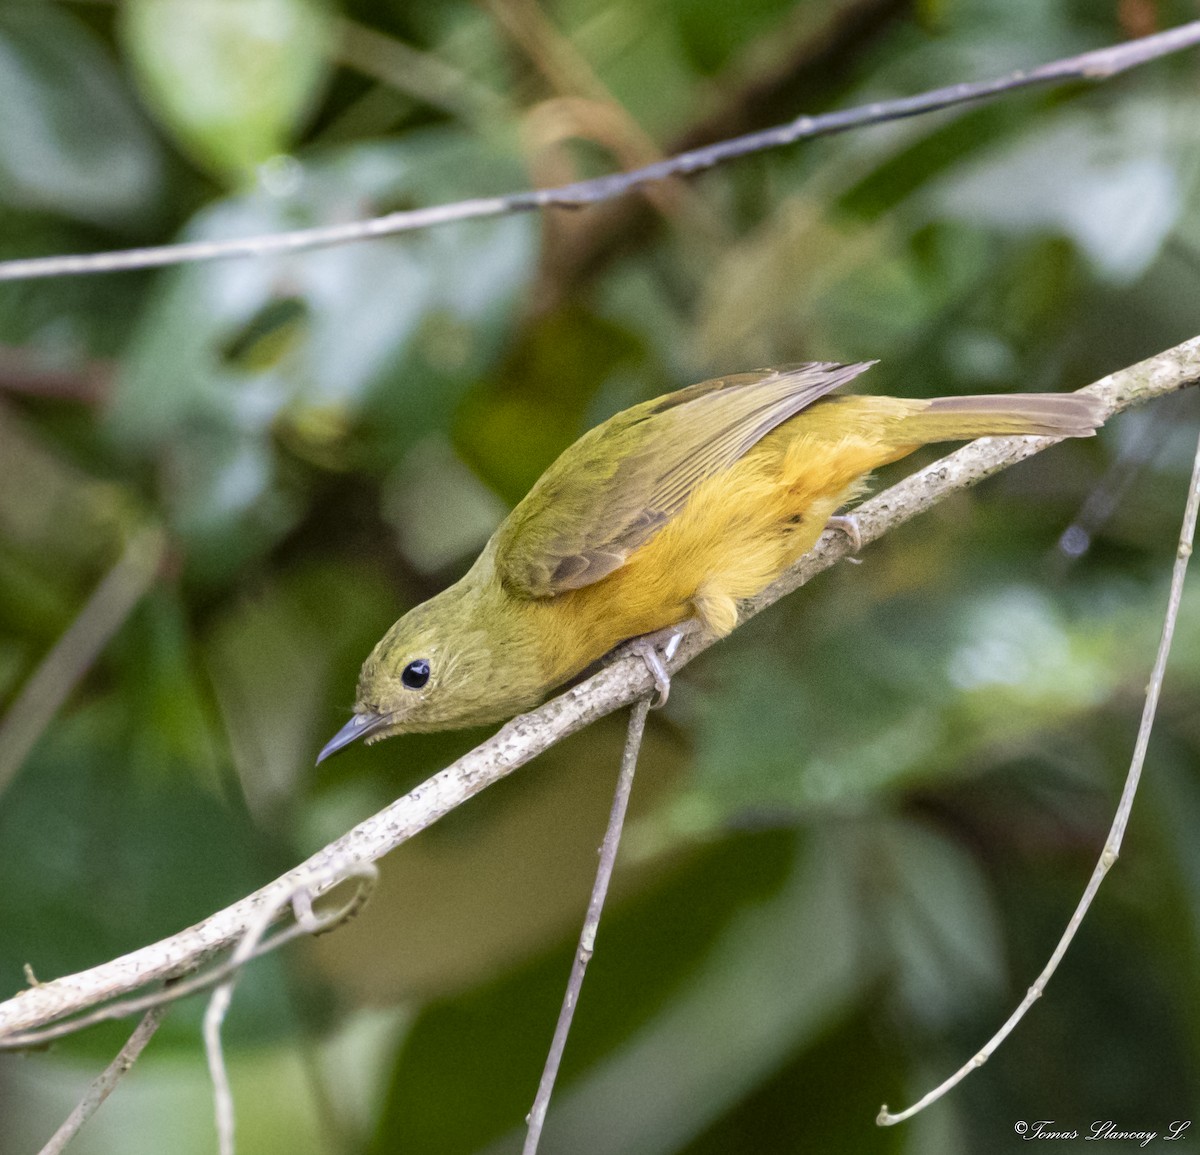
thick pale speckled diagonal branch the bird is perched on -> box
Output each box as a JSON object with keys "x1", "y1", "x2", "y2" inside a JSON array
[{"x1": 0, "y1": 328, "x2": 1200, "y2": 1046}]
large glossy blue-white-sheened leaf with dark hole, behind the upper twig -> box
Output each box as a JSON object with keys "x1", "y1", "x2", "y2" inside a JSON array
[{"x1": 109, "y1": 131, "x2": 534, "y2": 578}]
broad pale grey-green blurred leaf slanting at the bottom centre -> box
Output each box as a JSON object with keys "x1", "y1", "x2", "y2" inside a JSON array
[{"x1": 523, "y1": 836, "x2": 874, "y2": 1155}]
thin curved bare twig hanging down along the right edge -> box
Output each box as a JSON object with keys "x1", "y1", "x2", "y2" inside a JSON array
[{"x1": 875, "y1": 417, "x2": 1200, "y2": 1127}]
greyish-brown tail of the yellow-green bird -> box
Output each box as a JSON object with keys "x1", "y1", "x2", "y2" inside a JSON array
[{"x1": 906, "y1": 393, "x2": 1105, "y2": 442}]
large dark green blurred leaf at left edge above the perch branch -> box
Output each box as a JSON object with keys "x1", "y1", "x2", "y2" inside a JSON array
[{"x1": 0, "y1": 693, "x2": 258, "y2": 1037}]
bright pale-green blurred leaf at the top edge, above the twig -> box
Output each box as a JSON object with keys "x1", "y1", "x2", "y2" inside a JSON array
[{"x1": 121, "y1": 0, "x2": 334, "y2": 178}]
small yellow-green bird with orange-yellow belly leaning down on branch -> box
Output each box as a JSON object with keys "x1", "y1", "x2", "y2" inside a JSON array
[{"x1": 318, "y1": 361, "x2": 1103, "y2": 761}]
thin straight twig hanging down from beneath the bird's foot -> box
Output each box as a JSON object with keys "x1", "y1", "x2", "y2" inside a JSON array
[{"x1": 521, "y1": 696, "x2": 650, "y2": 1155}]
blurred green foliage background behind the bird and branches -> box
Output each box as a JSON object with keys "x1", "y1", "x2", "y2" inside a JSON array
[{"x1": 0, "y1": 0, "x2": 1200, "y2": 1155}]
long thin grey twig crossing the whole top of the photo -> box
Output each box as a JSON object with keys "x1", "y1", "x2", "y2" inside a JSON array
[{"x1": 0, "y1": 20, "x2": 1200, "y2": 281}]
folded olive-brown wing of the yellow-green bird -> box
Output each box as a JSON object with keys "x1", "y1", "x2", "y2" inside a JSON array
[{"x1": 496, "y1": 361, "x2": 875, "y2": 598}]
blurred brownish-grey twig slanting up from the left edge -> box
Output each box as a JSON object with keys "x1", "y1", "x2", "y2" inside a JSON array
[{"x1": 0, "y1": 526, "x2": 166, "y2": 794}]
